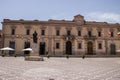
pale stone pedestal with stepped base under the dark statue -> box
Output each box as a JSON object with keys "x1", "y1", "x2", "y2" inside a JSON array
[{"x1": 25, "y1": 43, "x2": 44, "y2": 61}]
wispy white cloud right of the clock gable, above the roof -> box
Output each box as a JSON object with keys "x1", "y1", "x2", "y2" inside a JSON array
[{"x1": 86, "y1": 12, "x2": 120, "y2": 23}]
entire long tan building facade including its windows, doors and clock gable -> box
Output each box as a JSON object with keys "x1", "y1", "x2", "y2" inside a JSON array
[{"x1": 2, "y1": 15, "x2": 120, "y2": 56}]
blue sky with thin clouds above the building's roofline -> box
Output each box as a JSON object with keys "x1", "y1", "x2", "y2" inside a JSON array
[{"x1": 0, "y1": 0, "x2": 120, "y2": 29}]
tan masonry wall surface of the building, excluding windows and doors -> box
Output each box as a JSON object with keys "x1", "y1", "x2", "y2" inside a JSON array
[{"x1": 2, "y1": 15, "x2": 120, "y2": 56}]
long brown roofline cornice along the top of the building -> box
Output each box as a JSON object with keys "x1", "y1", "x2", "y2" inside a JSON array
[{"x1": 2, "y1": 19, "x2": 120, "y2": 28}]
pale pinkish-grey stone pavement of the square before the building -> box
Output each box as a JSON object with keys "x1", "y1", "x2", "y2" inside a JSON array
[{"x1": 0, "y1": 57, "x2": 120, "y2": 80}]
